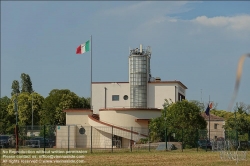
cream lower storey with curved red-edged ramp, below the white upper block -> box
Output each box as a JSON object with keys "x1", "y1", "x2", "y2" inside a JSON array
[{"x1": 56, "y1": 108, "x2": 161, "y2": 148}]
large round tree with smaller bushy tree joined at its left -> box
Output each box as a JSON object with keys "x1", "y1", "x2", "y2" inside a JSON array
[{"x1": 150, "y1": 100, "x2": 207, "y2": 146}]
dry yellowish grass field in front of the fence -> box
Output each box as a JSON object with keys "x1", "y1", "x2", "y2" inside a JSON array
[{"x1": 1, "y1": 150, "x2": 250, "y2": 166}]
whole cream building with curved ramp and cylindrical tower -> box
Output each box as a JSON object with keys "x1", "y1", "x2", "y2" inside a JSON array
[{"x1": 56, "y1": 45, "x2": 187, "y2": 148}]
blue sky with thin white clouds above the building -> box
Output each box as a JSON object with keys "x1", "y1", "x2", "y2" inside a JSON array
[{"x1": 1, "y1": 1, "x2": 250, "y2": 110}]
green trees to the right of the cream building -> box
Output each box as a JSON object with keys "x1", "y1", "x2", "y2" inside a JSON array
[{"x1": 149, "y1": 100, "x2": 250, "y2": 147}]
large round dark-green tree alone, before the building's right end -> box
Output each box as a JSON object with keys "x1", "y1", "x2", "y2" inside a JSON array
[{"x1": 165, "y1": 100, "x2": 207, "y2": 147}]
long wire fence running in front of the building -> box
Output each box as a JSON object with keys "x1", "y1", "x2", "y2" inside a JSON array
[{"x1": 3, "y1": 124, "x2": 250, "y2": 153}]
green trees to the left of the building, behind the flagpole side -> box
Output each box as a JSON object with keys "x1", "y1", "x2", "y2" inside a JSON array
[{"x1": 0, "y1": 73, "x2": 90, "y2": 134}]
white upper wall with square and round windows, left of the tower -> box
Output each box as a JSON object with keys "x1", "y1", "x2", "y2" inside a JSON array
[{"x1": 92, "y1": 82, "x2": 130, "y2": 113}]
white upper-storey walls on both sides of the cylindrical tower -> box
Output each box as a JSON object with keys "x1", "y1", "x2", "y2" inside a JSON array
[{"x1": 92, "y1": 81, "x2": 186, "y2": 114}]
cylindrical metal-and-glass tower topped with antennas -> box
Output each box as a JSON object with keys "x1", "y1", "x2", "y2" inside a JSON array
[{"x1": 129, "y1": 45, "x2": 151, "y2": 108}]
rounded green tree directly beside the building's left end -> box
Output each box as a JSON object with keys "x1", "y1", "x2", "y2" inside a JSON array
[{"x1": 40, "y1": 89, "x2": 84, "y2": 125}]
